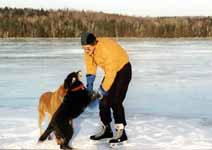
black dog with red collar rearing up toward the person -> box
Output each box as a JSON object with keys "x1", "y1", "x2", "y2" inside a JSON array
[{"x1": 39, "y1": 72, "x2": 92, "y2": 149}]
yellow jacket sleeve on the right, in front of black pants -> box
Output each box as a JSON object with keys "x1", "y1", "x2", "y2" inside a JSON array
[{"x1": 102, "y1": 52, "x2": 117, "y2": 92}]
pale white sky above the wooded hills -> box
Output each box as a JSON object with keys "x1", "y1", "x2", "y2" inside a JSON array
[{"x1": 0, "y1": 0, "x2": 212, "y2": 17}]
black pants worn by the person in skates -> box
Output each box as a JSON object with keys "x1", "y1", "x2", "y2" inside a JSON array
[{"x1": 99, "y1": 63, "x2": 132, "y2": 126}]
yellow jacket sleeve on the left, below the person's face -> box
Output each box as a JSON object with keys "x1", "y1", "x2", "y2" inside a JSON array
[{"x1": 84, "y1": 53, "x2": 97, "y2": 75}]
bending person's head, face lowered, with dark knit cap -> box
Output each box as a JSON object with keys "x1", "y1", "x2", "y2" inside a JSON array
[{"x1": 81, "y1": 32, "x2": 97, "y2": 55}]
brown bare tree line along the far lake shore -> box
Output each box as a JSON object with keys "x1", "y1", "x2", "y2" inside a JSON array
[{"x1": 0, "y1": 7, "x2": 212, "y2": 38}]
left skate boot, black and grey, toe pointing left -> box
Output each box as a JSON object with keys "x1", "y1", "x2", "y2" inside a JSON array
[{"x1": 90, "y1": 124, "x2": 113, "y2": 140}]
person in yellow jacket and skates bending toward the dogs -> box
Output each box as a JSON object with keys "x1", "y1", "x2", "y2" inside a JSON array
[{"x1": 81, "y1": 32, "x2": 132, "y2": 143}]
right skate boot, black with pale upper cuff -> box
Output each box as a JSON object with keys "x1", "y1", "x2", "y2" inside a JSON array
[{"x1": 109, "y1": 124, "x2": 127, "y2": 147}]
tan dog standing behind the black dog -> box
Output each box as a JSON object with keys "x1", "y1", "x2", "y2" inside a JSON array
[{"x1": 38, "y1": 85, "x2": 67, "y2": 135}]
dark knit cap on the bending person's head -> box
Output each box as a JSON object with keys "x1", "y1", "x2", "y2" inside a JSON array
[{"x1": 81, "y1": 32, "x2": 96, "y2": 45}]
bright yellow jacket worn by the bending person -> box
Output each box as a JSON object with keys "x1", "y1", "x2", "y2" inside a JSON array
[{"x1": 84, "y1": 38, "x2": 129, "y2": 91}]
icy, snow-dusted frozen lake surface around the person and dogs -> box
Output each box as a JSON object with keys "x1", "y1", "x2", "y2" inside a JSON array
[{"x1": 0, "y1": 39, "x2": 212, "y2": 150}]
